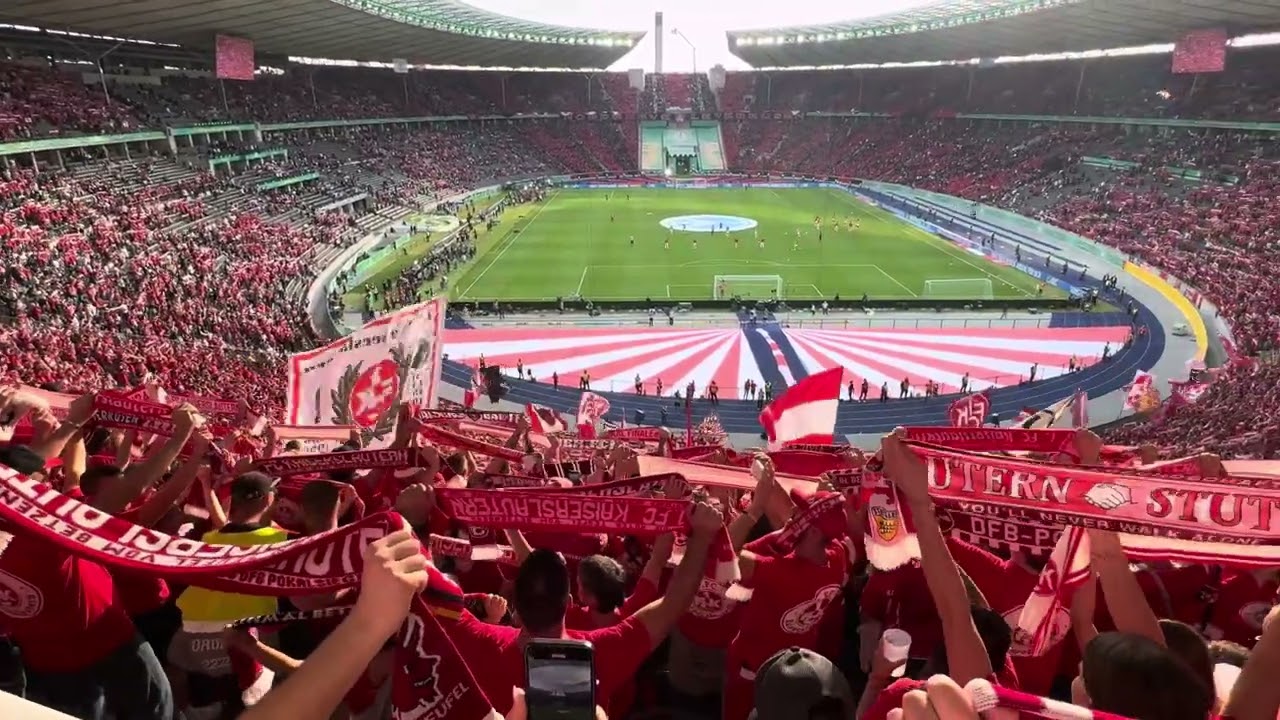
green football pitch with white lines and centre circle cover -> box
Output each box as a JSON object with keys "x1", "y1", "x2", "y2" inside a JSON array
[{"x1": 449, "y1": 188, "x2": 1062, "y2": 301}]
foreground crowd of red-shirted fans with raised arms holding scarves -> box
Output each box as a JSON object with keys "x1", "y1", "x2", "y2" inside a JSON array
[{"x1": 0, "y1": 387, "x2": 1280, "y2": 720}]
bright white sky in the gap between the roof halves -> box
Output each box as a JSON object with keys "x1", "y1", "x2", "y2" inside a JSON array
[{"x1": 466, "y1": 0, "x2": 940, "y2": 73}]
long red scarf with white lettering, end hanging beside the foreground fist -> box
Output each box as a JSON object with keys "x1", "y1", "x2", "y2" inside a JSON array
[{"x1": 0, "y1": 468, "x2": 492, "y2": 720}]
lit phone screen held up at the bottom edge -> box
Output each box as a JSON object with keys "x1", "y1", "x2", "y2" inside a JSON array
[{"x1": 525, "y1": 643, "x2": 595, "y2": 720}]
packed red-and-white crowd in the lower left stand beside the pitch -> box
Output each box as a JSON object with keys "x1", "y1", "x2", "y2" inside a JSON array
[{"x1": 0, "y1": 123, "x2": 614, "y2": 410}]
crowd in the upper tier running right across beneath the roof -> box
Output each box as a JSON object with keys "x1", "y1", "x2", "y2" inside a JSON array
[{"x1": 0, "y1": 47, "x2": 1280, "y2": 138}]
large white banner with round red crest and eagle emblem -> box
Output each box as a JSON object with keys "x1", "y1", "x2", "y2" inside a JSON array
[{"x1": 284, "y1": 299, "x2": 444, "y2": 450}]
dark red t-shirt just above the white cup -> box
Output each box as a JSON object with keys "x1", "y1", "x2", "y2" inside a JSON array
[{"x1": 860, "y1": 562, "x2": 942, "y2": 659}]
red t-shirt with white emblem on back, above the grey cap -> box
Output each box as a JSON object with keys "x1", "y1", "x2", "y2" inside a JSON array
[{"x1": 728, "y1": 541, "x2": 849, "y2": 673}]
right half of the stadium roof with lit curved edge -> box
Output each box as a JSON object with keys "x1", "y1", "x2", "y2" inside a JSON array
[{"x1": 728, "y1": 0, "x2": 1280, "y2": 67}]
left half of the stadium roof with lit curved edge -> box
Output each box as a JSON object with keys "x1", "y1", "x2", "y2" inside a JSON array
[{"x1": 0, "y1": 0, "x2": 644, "y2": 68}]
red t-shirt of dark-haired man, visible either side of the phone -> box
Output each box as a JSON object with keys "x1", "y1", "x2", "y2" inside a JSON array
[{"x1": 443, "y1": 604, "x2": 653, "y2": 715}]
